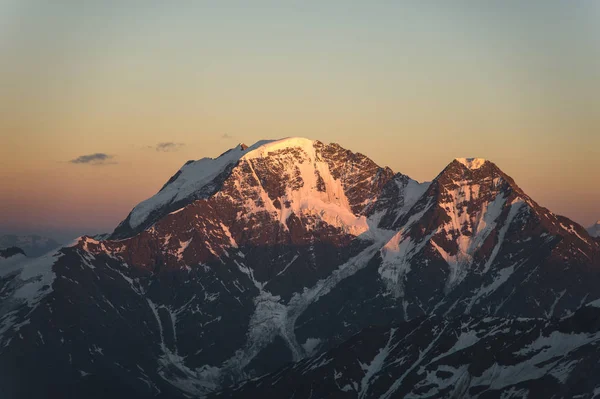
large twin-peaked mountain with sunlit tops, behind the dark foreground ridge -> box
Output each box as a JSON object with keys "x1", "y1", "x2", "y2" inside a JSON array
[{"x1": 0, "y1": 139, "x2": 600, "y2": 398}]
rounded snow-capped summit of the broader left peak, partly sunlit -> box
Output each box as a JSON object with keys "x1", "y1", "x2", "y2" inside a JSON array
[{"x1": 111, "y1": 137, "x2": 422, "y2": 238}]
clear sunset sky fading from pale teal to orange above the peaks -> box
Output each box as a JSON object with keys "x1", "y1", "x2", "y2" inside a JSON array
[{"x1": 0, "y1": 0, "x2": 600, "y2": 241}]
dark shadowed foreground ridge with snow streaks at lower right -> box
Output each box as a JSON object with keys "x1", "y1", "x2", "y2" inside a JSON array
[{"x1": 220, "y1": 306, "x2": 600, "y2": 399}]
